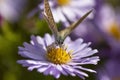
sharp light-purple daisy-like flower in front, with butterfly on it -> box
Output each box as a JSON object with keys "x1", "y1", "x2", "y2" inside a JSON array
[{"x1": 18, "y1": 34, "x2": 99, "y2": 79}]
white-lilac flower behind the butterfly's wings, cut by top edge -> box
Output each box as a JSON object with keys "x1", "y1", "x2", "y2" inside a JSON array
[{"x1": 39, "y1": 0, "x2": 95, "y2": 26}]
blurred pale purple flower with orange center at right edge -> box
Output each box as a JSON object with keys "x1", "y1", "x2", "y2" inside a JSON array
[{"x1": 94, "y1": 4, "x2": 120, "y2": 55}]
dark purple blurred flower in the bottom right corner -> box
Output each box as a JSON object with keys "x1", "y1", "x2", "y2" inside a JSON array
[{"x1": 97, "y1": 59, "x2": 120, "y2": 80}]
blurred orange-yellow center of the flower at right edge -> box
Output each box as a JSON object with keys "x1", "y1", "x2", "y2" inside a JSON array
[{"x1": 109, "y1": 23, "x2": 120, "y2": 40}]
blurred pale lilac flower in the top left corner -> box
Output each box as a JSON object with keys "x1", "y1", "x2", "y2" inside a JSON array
[{"x1": 0, "y1": 0, "x2": 26, "y2": 22}]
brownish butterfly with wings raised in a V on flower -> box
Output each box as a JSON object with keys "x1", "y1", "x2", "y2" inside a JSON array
[{"x1": 43, "y1": 0, "x2": 92, "y2": 45}]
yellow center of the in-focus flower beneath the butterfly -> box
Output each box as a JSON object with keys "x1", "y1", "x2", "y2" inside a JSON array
[{"x1": 46, "y1": 48, "x2": 71, "y2": 64}]
